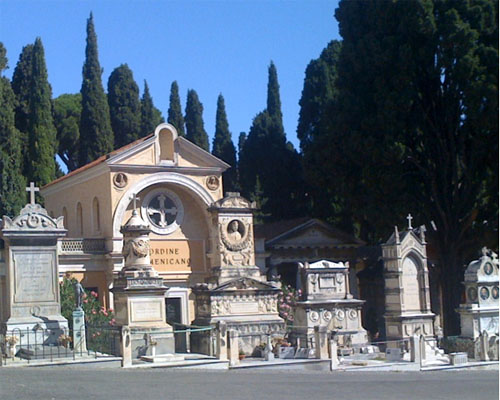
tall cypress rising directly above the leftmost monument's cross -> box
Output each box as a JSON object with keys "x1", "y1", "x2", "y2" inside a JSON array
[{"x1": 27, "y1": 38, "x2": 56, "y2": 185}]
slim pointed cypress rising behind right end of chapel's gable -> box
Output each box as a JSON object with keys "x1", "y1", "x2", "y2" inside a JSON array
[{"x1": 212, "y1": 94, "x2": 238, "y2": 192}]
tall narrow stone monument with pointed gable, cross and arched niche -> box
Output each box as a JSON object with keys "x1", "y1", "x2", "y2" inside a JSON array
[{"x1": 382, "y1": 215, "x2": 434, "y2": 340}]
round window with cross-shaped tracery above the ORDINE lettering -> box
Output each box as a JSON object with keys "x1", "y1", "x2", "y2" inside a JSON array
[{"x1": 141, "y1": 189, "x2": 184, "y2": 235}]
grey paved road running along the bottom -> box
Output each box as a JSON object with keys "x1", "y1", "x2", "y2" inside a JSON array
[{"x1": 0, "y1": 366, "x2": 498, "y2": 400}]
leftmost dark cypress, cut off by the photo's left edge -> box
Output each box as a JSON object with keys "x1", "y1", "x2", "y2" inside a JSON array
[{"x1": 0, "y1": 42, "x2": 26, "y2": 216}]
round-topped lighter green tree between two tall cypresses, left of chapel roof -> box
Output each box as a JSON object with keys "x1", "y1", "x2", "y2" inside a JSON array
[{"x1": 52, "y1": 93, "x2": 82, "y2": 171}]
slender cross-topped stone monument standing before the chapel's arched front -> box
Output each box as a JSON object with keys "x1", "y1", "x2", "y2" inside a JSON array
[{"x1": 112, "y1": 195, "x2": 175, "y2": 358}]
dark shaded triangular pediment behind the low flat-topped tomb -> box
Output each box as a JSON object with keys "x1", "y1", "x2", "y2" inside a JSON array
[{"x1": 266, "y1": 219, "x2": 363, "y2": 246}]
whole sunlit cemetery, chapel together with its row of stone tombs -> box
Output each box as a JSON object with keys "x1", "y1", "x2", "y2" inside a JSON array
[{"x1": 0, "y1": 124, "x2": 499, "y2": 371}]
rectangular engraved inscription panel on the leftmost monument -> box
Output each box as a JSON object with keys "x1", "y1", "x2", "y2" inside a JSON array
[{"x1": 14, "y1": 252, "x2": 56, "y2": 303}]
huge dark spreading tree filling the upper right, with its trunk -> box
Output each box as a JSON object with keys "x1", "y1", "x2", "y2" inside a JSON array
[{"x1": 299, "y1": 0, "x2": 498, "y2": 335}]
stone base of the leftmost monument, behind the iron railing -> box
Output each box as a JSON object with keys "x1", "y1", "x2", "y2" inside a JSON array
[{"x1": 1, "y1": 315, "x2": 69, "y2": 348}]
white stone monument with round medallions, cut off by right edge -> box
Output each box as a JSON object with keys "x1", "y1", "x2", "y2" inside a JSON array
[{"x1": 457, "y1": 248, "x2": 498, "y2": 340}]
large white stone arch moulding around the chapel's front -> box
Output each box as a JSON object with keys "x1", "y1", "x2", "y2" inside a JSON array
[{"x1": 113, "y1": 172, "x2": 214, "y2": 238}]
